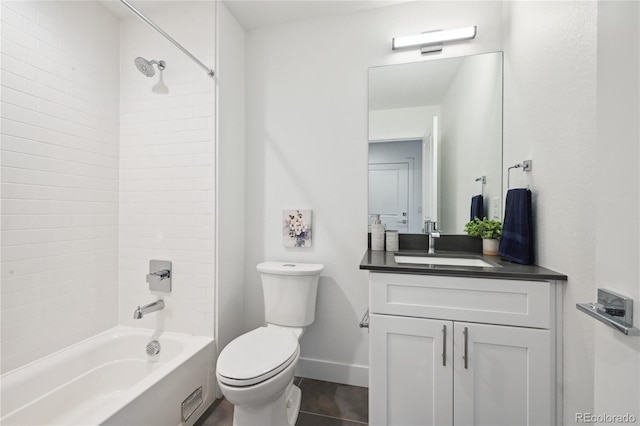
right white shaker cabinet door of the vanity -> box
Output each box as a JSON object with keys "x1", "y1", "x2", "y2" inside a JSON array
[{"x1": 453, "y1": 322, "x2": 555, "y2": 426}]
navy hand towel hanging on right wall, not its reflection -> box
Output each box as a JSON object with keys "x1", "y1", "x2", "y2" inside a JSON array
[{"x1": 498, "y1": 188, "x2": 533, "y2": 265}]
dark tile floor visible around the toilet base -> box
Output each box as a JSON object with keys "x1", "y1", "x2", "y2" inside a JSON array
[{"x1": 195, "y1": 378, "x2": 369, "y2": 426}]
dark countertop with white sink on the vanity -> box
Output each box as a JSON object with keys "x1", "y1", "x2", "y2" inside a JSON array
[{"x1": 360, "y1": 250, "x2": 567, "y2": 281}]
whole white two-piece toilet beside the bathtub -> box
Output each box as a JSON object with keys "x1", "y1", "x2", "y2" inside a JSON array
[{"x1": 216, "y1": 262, "x2": 323, "y2": 426}]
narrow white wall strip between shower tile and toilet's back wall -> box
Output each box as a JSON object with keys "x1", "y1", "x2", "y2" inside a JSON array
[{"x1": 215, "y1": 2, "x2": 245, "y2": 350}]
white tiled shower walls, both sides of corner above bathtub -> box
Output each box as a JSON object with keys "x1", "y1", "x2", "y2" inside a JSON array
[{"x1": 1, "y1": 1, "x2": 215, "y2": 372}]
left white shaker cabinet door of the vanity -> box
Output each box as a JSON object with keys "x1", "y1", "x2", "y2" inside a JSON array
[{"x1": 369, "y1": 314, "x2": 453, "y2": 426}]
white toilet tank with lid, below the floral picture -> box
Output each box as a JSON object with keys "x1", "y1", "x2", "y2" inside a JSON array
[{"x1": 257, "y1": 262, "x2": 324, "y2": 327}]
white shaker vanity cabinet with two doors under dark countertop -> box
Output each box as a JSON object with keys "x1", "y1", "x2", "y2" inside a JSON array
[{"x1": 369, "y1": 273, "x2": 560, "y2": 426}]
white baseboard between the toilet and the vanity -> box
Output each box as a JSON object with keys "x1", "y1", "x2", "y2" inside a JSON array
[{"x1": 296, "y1": 358, "x2": 369, "y2": 388}]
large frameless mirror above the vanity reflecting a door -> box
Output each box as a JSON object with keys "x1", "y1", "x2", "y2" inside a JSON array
[{"x1": 369, "y1": 52, "x2": 502, "y2": 234}]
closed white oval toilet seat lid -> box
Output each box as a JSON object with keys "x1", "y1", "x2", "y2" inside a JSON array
[{"x1": 216, "y1": 327, "x2": 300, "y2": 386}]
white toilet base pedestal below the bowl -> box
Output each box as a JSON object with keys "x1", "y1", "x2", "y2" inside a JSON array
[{"x1": 233, "y1": 380, "x2": 302, "y2": 426}]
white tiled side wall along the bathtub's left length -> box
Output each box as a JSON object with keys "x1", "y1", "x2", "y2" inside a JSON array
[{"x1": 0, "y1": 1, "x2": 119, "y2": 372}]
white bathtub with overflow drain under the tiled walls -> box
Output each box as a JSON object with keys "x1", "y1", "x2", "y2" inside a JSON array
[{"x1": 0, "y1": 327, "x2": 215, "y2": 426}]
